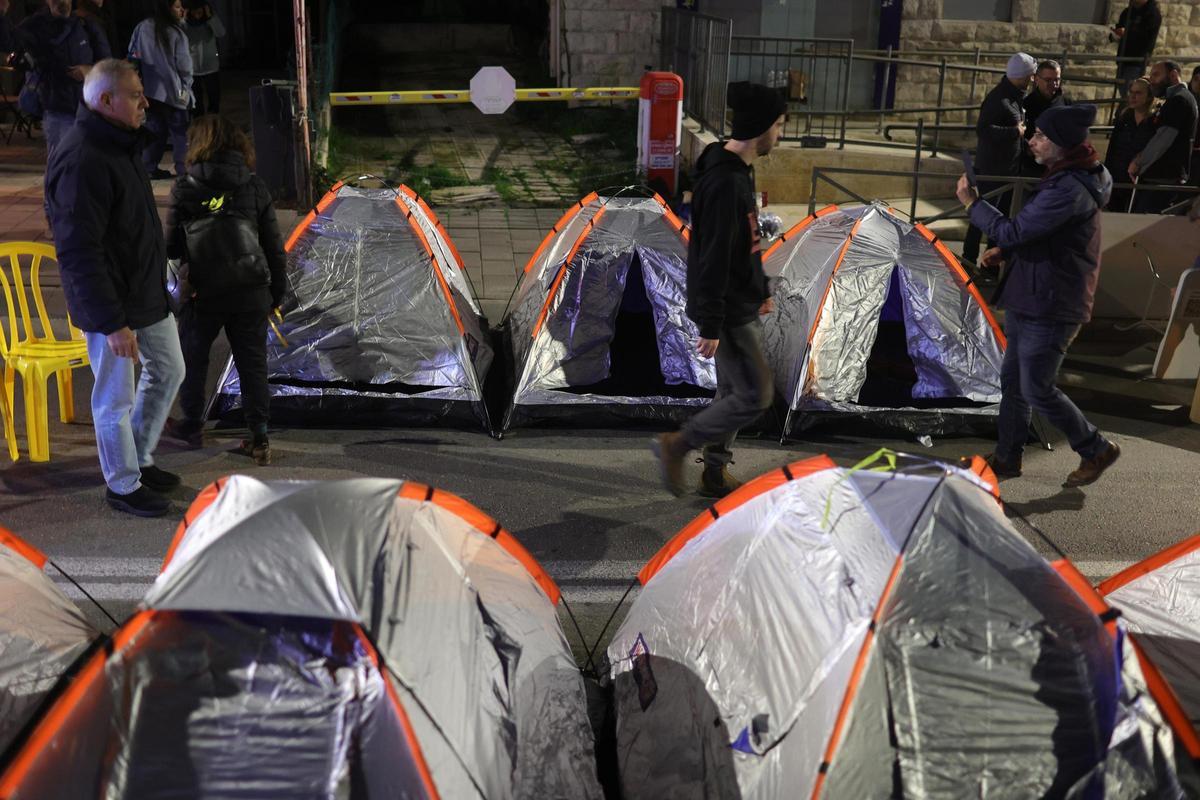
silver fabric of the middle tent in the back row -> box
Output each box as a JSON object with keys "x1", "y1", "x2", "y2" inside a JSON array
[{"x1": 506, "y1": 197, "x2": 716, "y2": 429}]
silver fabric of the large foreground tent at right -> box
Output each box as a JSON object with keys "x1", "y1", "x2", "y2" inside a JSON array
[{"x1": 608, "y1": 468, "x2": 1177, "y2": 799}]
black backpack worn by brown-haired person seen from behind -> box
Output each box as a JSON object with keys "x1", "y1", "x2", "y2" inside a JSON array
[{"x1": 184, "y1": 175, "x2": 271, "y2": 296}]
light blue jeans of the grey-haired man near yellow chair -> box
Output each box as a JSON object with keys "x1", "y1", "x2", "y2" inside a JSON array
[{"x1": 84, "y1": 314, "x2": 184, "y2": 494}]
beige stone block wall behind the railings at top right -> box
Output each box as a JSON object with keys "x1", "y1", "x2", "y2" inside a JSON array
[{"x1": 895, "y1": 0, "x2": 1200, "y2": 128}]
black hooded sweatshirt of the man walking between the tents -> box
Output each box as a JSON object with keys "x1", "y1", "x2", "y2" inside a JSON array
[{"x1": 688, "y1": 142, "x2": 770, "y2": 339}]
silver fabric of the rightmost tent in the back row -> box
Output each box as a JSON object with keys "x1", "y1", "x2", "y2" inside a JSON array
[{"x1": 763, "y1": 203, "x2": 1003, "y2": 434}]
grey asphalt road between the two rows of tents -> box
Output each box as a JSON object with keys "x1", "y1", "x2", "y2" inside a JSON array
[{"x1": 0, "y1": 326, "x2": 1200, "y2": 662}]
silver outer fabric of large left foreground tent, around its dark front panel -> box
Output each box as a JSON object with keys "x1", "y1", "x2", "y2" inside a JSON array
[{"x1": 145, "y1": 476, "x2": 600, "y2": 798}]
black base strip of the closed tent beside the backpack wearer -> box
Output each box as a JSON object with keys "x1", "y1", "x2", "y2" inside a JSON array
[{"x1": 211, "y1": 395, "x2": 492, "y2": 433}]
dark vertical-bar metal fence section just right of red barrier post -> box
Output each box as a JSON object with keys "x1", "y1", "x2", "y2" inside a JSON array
[{"x1": 659, "y1": 8, "x2": 733, "y2": 138}]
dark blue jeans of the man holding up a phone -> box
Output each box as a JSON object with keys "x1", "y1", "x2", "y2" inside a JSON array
[{"x1": 996, "y1": 312, "x2": 1109, "y2": 463}]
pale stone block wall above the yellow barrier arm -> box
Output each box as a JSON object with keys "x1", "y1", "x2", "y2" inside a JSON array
[{"x1": 559, "y1": 0, "x2": 662, "y2": 86}]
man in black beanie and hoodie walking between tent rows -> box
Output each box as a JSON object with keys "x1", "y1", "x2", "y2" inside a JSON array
[{"x1": 652, "y1": 83, "x2": 786, "y2": 498}]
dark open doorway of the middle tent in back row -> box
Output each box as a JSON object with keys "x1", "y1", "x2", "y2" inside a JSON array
[{"x1": 559, "y1": 249, "x2": 713, "y2": 397}]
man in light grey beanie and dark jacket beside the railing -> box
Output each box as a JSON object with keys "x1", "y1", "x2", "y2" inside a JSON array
[{"x1": 962, "y1": 53, "x2": 1038, "y2": 272}]
